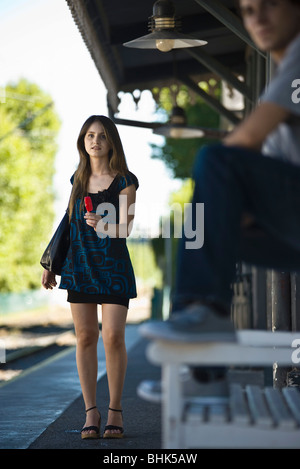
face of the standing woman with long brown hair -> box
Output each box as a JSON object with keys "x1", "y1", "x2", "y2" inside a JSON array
[{"x1": 84, "y1": 121, "x2": 111, "y2": 158}]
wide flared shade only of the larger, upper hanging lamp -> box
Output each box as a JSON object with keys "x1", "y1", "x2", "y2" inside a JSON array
[{"x1": 123, "y1": 30, "x2": 207, "y2": 50}]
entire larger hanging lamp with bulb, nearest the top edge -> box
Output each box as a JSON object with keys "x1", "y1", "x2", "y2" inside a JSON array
[{"x1": 123, "y1": 0, "x2": 207, "y2": 52}]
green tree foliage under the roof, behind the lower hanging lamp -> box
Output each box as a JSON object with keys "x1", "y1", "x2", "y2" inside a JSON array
[{"x1": 151, "y1": 79, "x2": 220, "y2": 179}]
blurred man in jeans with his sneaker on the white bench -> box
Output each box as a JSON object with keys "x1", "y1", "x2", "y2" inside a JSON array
[{"x1": 144, "y1": 0, "x2": 300, "y2": 342}]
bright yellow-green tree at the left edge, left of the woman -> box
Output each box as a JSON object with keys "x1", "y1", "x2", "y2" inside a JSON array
[{"x1": 0, "y1": 79, "x2": 60, "y2": 292}]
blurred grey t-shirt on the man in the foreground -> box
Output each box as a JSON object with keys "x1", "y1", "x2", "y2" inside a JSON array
[{"x1": 260, "y1": 35, "x2": 300, "y2": 165}]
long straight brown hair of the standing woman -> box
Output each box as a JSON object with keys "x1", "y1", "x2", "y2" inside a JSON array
[{"x1": 69, "y1": 115, "x2": 128, "y2": 220}]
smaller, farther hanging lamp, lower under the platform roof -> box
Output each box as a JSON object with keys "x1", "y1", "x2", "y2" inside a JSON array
[{"x1": 153, "y1": 106, "x2": 204, "y2": 138}]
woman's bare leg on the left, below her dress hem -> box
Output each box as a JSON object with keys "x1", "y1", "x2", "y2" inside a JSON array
[{"x1": 71, "y1": 303, "x2": 99, "y2": 432}]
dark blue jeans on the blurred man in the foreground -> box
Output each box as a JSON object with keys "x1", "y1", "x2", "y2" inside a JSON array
[{"x1": 172, "y1": 145, "x2": 300, "y2": 315}]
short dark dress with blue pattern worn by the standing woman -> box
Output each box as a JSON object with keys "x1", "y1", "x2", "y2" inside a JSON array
[{"x1": 59, "y1": 173, "x2": 139, "y2": 304}]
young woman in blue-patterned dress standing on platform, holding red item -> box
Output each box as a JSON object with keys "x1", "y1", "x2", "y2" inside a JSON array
[{"x1": 42, "y1": 116, "x2": 138, "y2": 438}]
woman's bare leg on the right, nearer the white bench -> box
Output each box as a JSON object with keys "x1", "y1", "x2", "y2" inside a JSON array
[{"x1": 102, "y1": 304, "x2": 127, "y2": 434}]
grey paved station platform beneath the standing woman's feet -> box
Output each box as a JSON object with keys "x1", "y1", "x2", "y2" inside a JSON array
[{"x1": 0, "y1": 325, "x2": 161, "y2": 450}]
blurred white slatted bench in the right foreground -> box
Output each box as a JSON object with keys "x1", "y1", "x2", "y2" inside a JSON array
[{"x1": 140, "y1": 326, "x2": 300, "y2": 449}]
